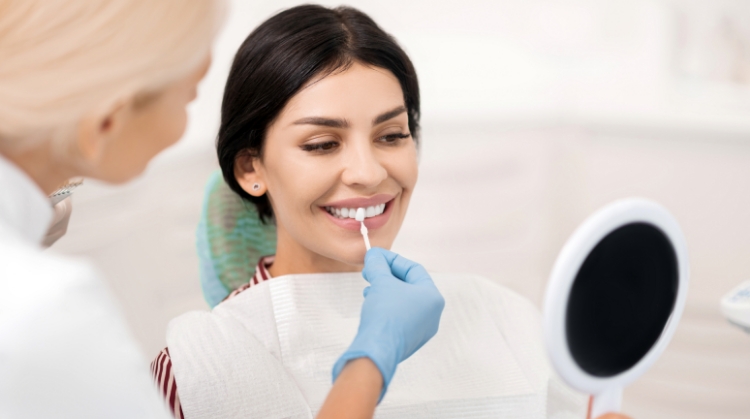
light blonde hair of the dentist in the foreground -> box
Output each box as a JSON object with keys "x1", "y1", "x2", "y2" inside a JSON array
[{"x1": 0, "y1": 0, "x2": 225, "y2": 151}]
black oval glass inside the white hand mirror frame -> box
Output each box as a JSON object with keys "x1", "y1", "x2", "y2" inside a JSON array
[{"x1": 565, "y1": 223, "x2": 678, "y2": 377}]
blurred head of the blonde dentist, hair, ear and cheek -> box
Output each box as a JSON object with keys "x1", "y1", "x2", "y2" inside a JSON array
[{"x1": 0, "y1": 0, "x2": 224, "y2": 193}]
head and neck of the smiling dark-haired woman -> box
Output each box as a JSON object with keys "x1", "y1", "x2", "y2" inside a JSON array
[{"x1": 213, "y1": 6, "x2": 419, "y2": 276}]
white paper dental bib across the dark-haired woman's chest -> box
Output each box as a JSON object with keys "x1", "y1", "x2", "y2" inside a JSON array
[{"x1": 167, "y1": 273, "x2": 587, "y2": 419}]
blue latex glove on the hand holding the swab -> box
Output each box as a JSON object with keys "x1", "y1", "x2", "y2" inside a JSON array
[{"x1": 333, "y1": 247, "x2": 445, "y2": 400}]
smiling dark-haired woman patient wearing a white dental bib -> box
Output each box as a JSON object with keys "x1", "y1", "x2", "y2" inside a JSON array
[{"x1": 153, "y1": 6, "x2": 585, "y2": 419}]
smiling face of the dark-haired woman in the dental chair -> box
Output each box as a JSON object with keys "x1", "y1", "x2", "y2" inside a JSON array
[{"x1": 238, "y1": 62, "x2": 417, "y2": 271}]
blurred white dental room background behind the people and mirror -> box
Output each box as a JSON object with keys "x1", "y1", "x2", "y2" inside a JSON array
[{"x1": 55, "y1": 0, "x2": 750, "y2": 419}]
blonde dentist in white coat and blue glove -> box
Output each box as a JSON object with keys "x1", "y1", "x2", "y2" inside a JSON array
[{"x1": 0, "y1": 0, "x2": 444, "y2": 418}]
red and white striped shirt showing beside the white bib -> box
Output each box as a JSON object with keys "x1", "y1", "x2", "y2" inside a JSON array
[{"x1": 151, "y1": 256, "x2": 274, "y2": 419}]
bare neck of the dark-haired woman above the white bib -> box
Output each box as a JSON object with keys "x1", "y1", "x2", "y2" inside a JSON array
[{"x1": 268, "y1": 225, "x2": 362, "y2": 277}]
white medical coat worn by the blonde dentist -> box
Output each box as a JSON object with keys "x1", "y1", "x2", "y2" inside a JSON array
[{"x1": 0, "y1": 156, "x2": 171, "y2": 419}]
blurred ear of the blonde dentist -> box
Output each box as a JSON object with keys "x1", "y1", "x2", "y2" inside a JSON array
[{"x1": 76, "y1": 100, "x2": 129, "y2": 164}]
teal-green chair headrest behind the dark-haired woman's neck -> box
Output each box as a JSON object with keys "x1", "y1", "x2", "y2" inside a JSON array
[{"x1": 196, "y1": 170, "x2": 276, "y2": 308}]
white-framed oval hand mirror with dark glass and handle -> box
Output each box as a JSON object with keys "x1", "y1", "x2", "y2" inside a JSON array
[{"x1": 544, "y1": 199, "x2": 689, "y2": 417}]
